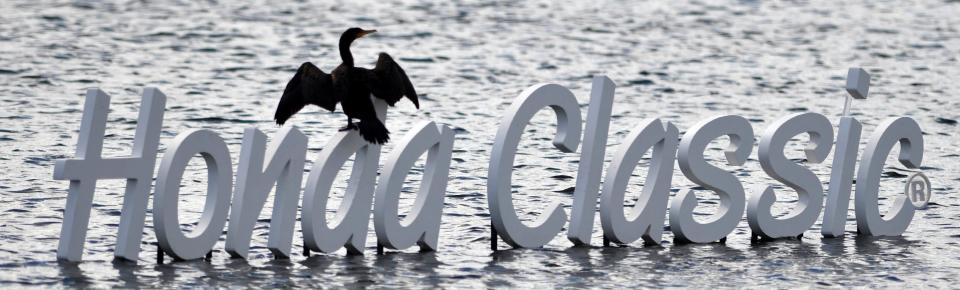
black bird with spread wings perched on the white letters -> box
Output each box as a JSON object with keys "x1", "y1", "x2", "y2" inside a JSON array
[{"x1": 273, "y1": 27, "x2": 420, "y2": 144}]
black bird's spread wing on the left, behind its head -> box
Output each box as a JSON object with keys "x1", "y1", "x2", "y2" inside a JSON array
[{"x1": 273, "y1": 62, "x2": 338, "y2": 125}]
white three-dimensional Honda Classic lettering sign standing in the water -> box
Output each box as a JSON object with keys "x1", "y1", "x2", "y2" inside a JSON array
[{"x1": 54, "y1": 76, "x2": 930, "y2": 261}]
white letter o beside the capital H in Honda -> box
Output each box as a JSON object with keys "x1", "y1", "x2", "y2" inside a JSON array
[{"x1": 153, "y1": 130, "x2": 233, "y2": 260}]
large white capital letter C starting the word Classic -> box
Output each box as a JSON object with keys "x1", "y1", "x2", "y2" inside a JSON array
[{"x1": 487, "y1": 84, "x2": 581, "y2": 248}]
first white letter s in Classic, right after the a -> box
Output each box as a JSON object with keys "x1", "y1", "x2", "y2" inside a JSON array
[{"x1": 670, "y1": 115, "x2": 753, "y2": 243}]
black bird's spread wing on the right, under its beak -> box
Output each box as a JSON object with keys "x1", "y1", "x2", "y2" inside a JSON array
[{"x1": 363, "y1": 52, "x2": 420, "y2": 109}]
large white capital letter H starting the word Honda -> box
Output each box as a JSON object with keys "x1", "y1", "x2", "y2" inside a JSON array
[{"x1": 53, "y1": 88, "x2": 167, "y2": 262}]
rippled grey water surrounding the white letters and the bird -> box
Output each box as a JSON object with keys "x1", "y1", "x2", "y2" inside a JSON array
[{"x1": 0, "y1": 0, "x2": 960, "y2": 288}]
